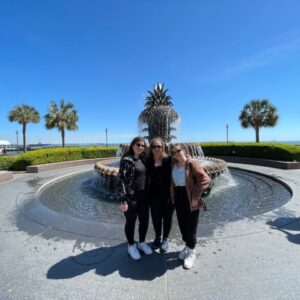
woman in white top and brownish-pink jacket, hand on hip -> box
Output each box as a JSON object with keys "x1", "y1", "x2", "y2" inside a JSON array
[{"x1": 171, "y1": 144, "x2": 210, "y2": 269}]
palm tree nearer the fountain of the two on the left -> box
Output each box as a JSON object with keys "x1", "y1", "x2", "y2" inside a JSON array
[{"x1": 44, "y1": 99, "x2": 79, "y2": 147}]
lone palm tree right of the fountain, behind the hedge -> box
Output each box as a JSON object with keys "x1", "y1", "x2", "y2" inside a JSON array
[{"x1": 239, "y1": 99, "x2": 279, "y2": 143}]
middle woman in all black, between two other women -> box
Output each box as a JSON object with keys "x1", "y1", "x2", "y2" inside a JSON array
[{"x1": 147, "y1": 138, "x2": 174, "y2": 252}]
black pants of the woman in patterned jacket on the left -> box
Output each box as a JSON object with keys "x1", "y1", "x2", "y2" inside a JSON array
[{"x1": 124, "y1": 190, "x2": 149, "y2": 245}]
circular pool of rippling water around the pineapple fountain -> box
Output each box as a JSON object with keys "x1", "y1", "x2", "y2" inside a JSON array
[{"x1": 39, "y1": 169, "x2": 291, "y2": 224}]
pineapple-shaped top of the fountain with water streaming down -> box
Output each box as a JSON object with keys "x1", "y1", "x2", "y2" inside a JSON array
[{"x1": 139, "y1": 83, "x2": 179, "y2": 143}]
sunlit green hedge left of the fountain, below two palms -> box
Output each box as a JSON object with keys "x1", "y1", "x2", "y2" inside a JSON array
[{"x1": 10, "y1": 147, "x2": 116, "y2": 171}]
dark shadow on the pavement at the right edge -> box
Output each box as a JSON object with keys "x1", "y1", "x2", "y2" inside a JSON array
[{"x1": 267, "y1": 217, "x2": 300, "y2": 244}]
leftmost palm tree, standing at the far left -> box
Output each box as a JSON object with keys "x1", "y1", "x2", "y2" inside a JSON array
[{"x1": 8, "y1": 104, "x2": 40, "y2": 152}]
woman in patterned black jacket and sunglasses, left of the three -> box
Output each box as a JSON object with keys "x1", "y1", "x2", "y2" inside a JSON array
[{"x1": 119, "y1": 137, "x2": 153, "y2": 260}]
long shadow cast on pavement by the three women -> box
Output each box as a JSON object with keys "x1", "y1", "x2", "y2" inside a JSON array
[{"x1": 47, "y1": 243, "x2": 181, "y2": 280}]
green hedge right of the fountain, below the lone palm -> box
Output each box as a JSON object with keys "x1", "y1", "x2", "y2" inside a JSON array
[{"x1": 200, "y1": 143, "x2": 300, "y2": 161}]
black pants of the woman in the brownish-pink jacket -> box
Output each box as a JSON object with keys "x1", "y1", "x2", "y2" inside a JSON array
[{"x1": 175, "y1": 187, "x2": 199, "y2": 249}]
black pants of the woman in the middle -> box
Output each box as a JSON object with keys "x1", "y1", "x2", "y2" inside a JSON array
[{"x1": 150, "y1": 191, "x2": 174, "y2": 239}]
